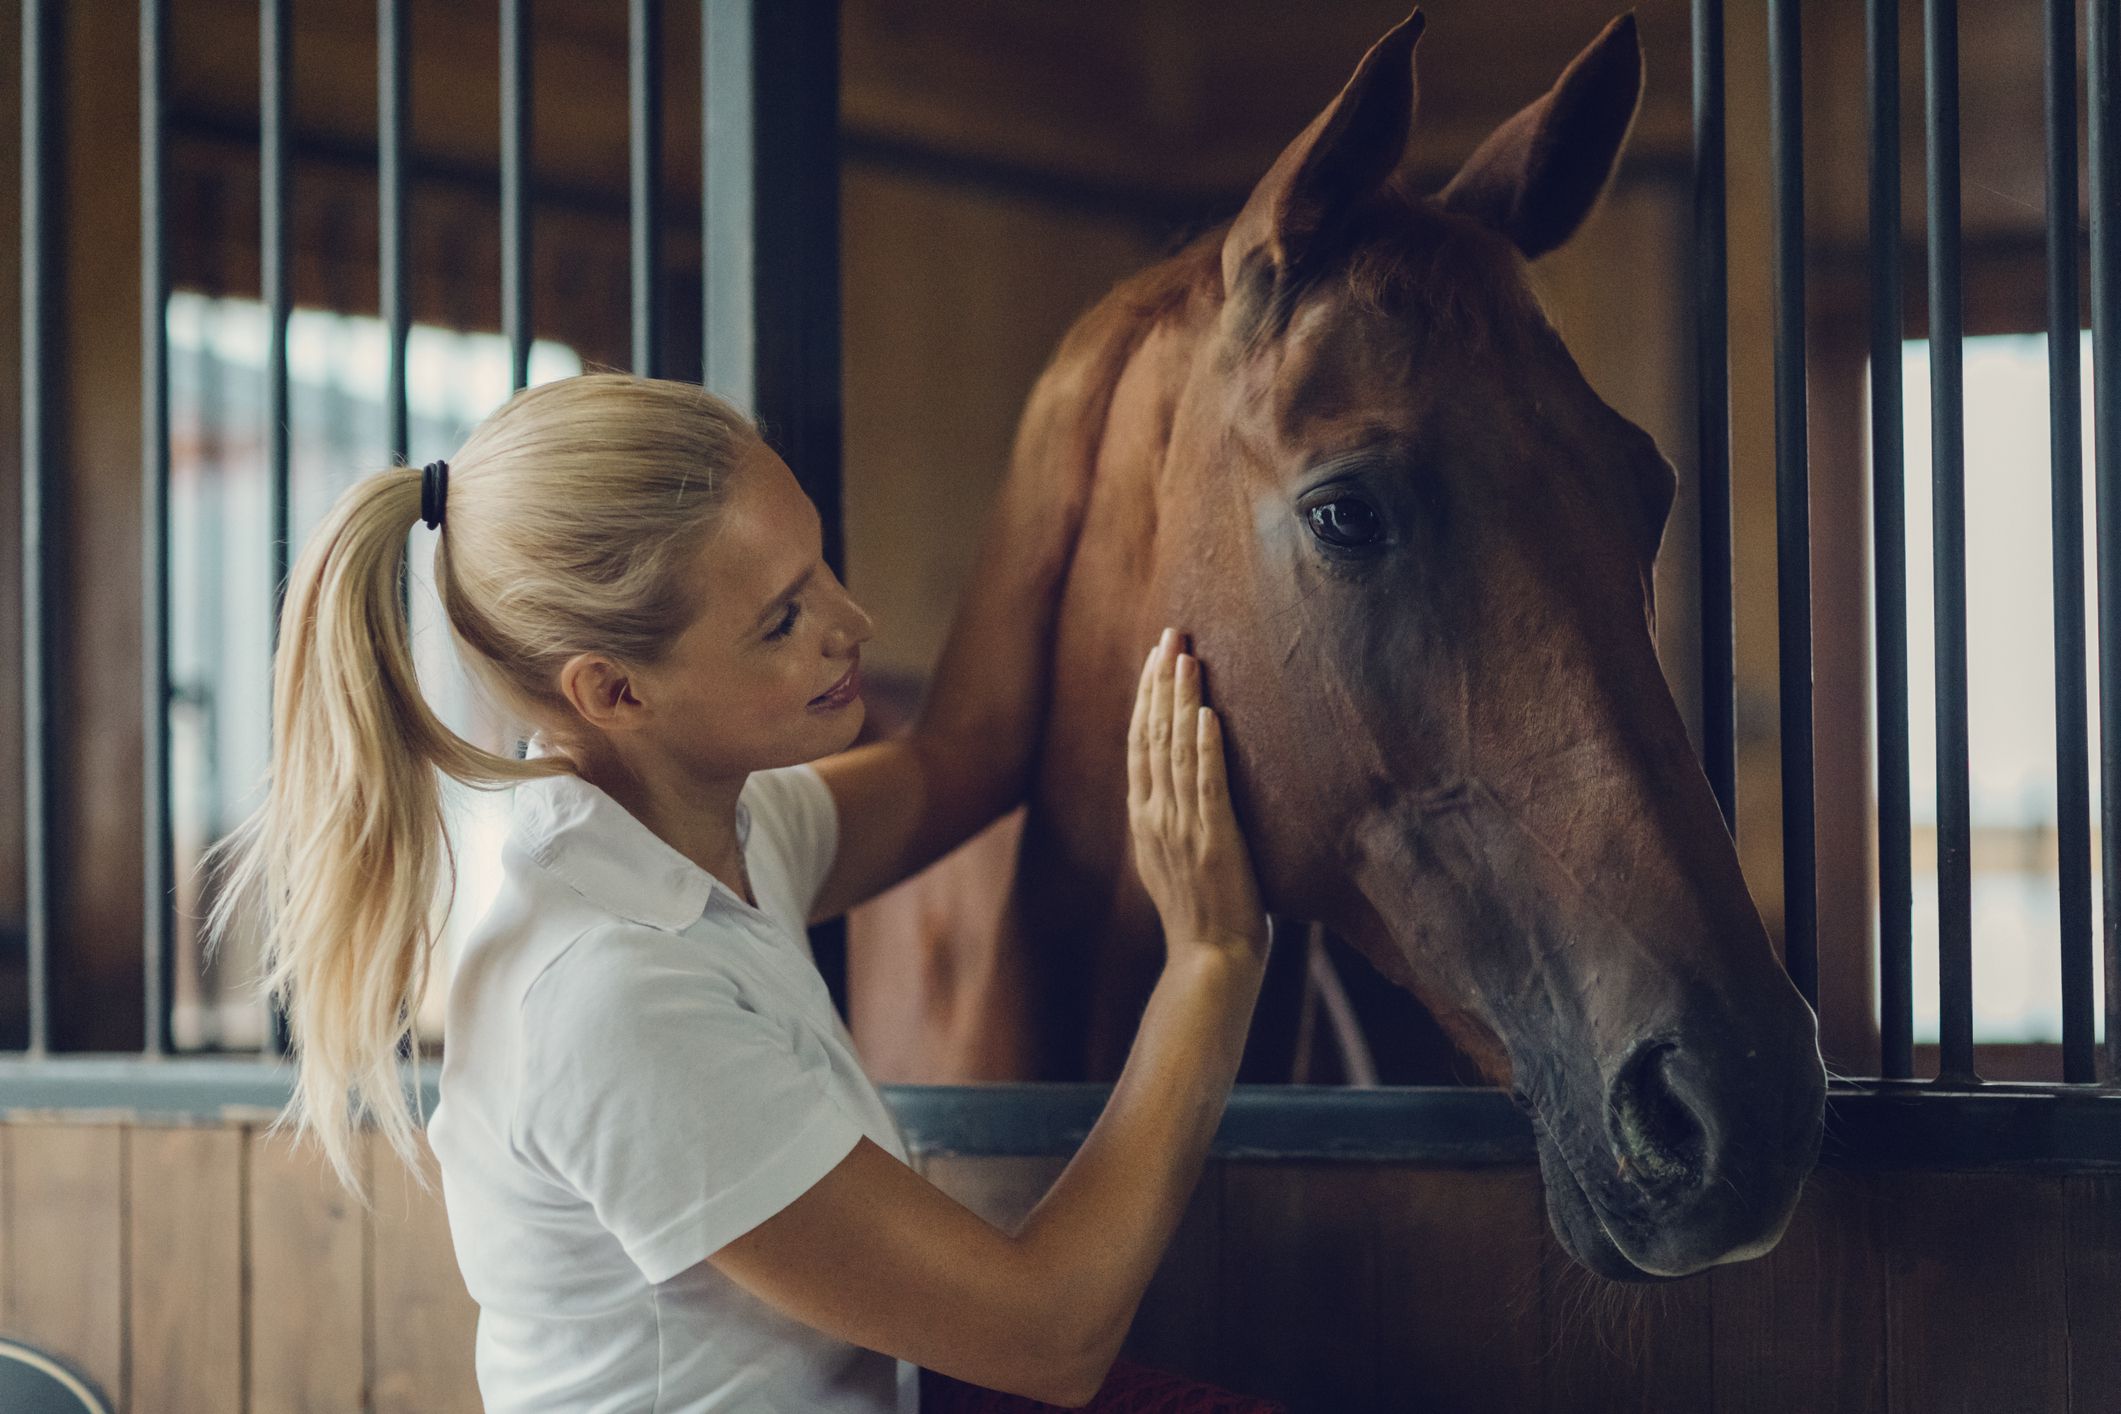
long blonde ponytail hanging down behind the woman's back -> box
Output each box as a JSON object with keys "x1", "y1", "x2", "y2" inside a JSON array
[{"x1": 206, "y1": 466, "x2": 564, "y2": 1196}]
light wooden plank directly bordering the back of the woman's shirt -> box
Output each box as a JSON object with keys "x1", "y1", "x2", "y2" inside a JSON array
[{"x1": 377, "y1": 1132, "x2": 481, "y2": 1414}]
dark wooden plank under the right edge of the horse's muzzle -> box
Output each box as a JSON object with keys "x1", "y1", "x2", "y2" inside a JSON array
[{"x1": 1710, "y1": 1170, "x2": 1886, "y2": 1414}]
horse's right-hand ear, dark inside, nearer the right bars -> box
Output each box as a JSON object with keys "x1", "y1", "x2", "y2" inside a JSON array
[{"x1": 1436, "y1": 11, "x2": 1642, "y2": 259}]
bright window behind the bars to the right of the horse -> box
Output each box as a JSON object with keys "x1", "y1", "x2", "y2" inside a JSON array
[{"x1": 1871, "y1": 333, "x2": 2104, "y2": 1043}]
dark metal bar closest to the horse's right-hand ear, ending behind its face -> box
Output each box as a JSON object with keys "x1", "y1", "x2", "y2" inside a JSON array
[{"x1": 1693, "y1": 0, "x2": 1737, "y2": 839}]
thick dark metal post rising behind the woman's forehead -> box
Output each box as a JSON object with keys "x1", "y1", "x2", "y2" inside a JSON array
[{"x1": 700, "y1": 0, "x2": 846, "y2": 1015}]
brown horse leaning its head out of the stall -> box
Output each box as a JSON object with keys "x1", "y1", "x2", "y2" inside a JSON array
[{"x1": 851, "y1": 11, "x2": 1826, "y2": 1280}]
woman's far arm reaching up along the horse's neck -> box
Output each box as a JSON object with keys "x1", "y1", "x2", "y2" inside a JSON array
[{"x1": 810, "y1": 443, "x2": 1084, "y2": 922}]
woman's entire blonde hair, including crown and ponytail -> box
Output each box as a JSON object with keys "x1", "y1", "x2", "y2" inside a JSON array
[{"x1": 206, "y1": 373, "x2": 757, "y2": 1200}]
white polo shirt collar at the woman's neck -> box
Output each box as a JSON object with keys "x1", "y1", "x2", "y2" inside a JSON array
[{"x1": 509, "y1": 736, "x2": 751, "y2": 933}]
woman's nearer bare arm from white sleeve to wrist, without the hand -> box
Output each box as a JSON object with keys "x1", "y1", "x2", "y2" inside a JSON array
[{"x1": 708, "y1": 958, "x2": 1262, "y2": 1408}]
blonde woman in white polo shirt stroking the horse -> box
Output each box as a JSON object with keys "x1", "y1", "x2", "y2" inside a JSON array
[{"x1": 212, "y1": 375, "x2": 1266, "y2": 1412}]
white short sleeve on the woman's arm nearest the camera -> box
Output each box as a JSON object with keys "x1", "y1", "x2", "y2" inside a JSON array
[{"x1": 515, "y1": 926, "x2": 863, "y2": 1283}]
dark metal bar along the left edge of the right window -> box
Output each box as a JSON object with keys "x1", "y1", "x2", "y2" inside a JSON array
[{"x1": 1864, "y1": 0, "x2": 1915, "y2": 1079}]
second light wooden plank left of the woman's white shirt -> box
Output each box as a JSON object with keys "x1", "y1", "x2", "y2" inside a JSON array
[{"x1": 246, "y1": 1130, "x2": 367, "y2": 1414}]
